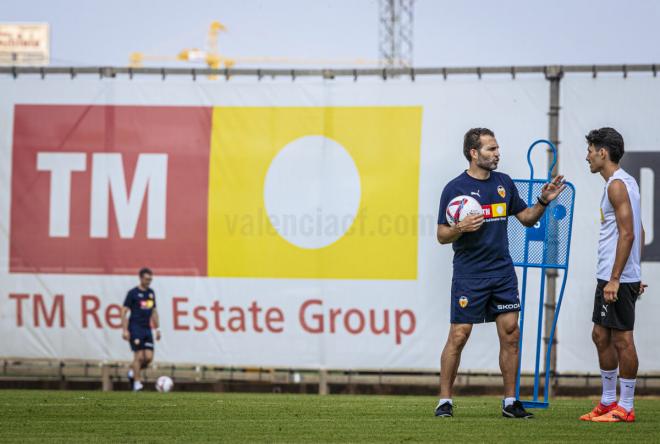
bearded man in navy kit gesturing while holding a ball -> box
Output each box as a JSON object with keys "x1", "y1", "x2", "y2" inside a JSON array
[{"x1": 435, "y1": 128, "x2": 565, "y2": 418}]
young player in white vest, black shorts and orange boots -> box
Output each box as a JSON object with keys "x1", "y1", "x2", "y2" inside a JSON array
[{"x1": 580, "y1": 128, "x2": 646, "y2": 422}]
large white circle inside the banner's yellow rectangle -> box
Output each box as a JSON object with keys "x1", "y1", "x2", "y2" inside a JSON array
[{"x1": 264, "y1": 136, "x2": 361, "y2": 249}]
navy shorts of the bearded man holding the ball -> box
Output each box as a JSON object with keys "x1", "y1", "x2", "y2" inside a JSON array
[{"x1": 451, "y1": 273, "x2": 520, "y2": 324}]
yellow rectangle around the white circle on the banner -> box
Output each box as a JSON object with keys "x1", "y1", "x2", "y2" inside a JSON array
[{"x1": 208, "y1": 107, "x2": 422, "y2": 279}]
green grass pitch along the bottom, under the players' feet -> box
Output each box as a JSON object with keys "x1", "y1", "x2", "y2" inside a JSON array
[{"x1": 0, "y1": 390, "x2": 660, "y2": 443}]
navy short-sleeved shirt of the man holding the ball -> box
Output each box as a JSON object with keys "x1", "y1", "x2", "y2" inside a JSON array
[{"x1": 438, "y1": 171, "x2": 527, "y2": 278}]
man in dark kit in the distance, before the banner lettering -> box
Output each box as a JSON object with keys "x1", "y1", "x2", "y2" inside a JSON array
[{"x1": 121, "y1": 268, "x2": 160, "y2": 392}]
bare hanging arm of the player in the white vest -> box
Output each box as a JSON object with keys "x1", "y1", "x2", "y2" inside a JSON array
[{"x1": 603, "y1": 180, "x2": 635, "y2": 303}]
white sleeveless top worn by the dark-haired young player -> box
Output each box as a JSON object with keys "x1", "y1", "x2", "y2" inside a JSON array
[{"x1": 596, "y1": 168, "x2": 642, "y2": 283}]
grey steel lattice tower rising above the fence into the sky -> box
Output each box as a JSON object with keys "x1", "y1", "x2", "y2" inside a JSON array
[{"x1": 378, "y1": 0, "x2": 415, "y2": 68}]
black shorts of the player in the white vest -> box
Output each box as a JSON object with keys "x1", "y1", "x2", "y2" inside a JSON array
[{"x1": 591, "y1": 279, "x2": 640, "y2": 331}]
